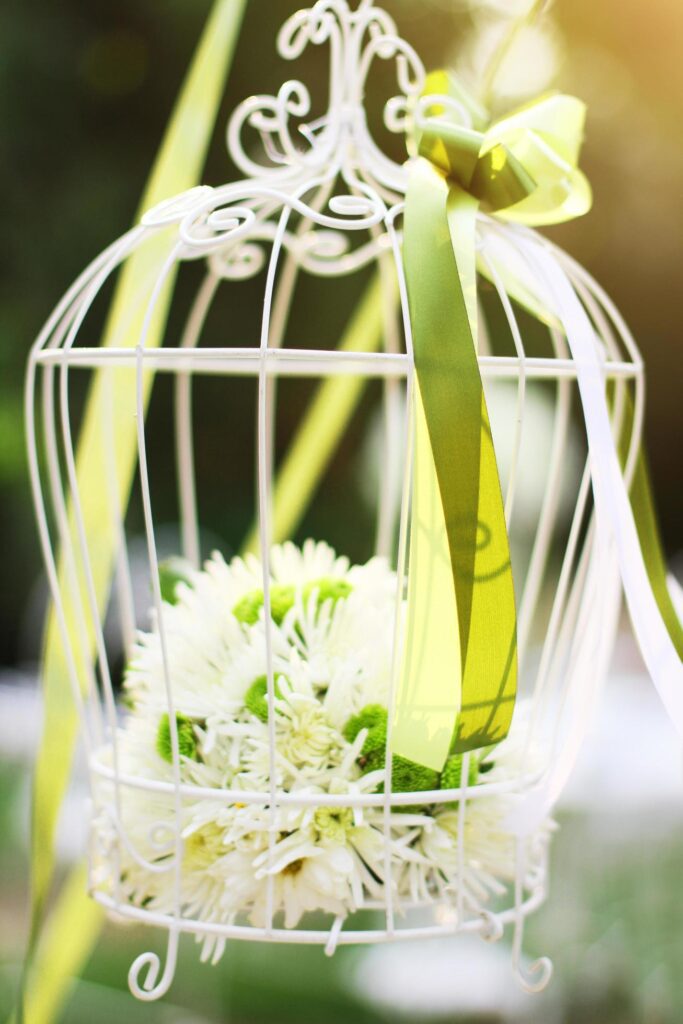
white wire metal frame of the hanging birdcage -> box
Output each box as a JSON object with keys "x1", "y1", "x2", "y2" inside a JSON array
[{"x1": 27, "y1": 0, "x2": 643, "y2": 999}]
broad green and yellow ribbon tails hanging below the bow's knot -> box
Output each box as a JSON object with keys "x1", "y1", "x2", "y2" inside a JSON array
[{"x1": 393, "y1": 160, "x2": 517, "y2": 770}]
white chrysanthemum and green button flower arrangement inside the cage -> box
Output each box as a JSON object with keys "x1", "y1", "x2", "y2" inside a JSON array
[{"x1": 94, "y1": 541, "x2": 549, "y2": 958}]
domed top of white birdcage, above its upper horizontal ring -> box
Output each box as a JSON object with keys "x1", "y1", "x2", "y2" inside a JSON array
[{"x1": 34, "y1": 0, "x2": 642, "y2": 391}]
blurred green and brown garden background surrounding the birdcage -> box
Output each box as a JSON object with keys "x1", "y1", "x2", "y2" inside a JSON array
[{"x1": 0, "y1": 0, "x2": 683, "y2": 1024}]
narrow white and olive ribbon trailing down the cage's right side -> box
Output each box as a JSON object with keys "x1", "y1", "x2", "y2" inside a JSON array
[{"x1": 503, "y1": 239, "x2": 683, "y2": 835}]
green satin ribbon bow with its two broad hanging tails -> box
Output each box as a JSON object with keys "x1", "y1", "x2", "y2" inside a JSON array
[{"x1": 393, "y1": 72, "x2": 591, "y2": 770}]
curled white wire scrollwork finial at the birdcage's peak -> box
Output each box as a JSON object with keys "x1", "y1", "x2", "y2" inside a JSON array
[{"x1": 137, "y1": 0, "x2": 421, "y2": 264}]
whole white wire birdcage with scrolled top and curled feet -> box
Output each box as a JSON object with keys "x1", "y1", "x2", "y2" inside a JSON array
[{"x1": 28, "y1": 0, "x2": 679, "y2": 999}]
